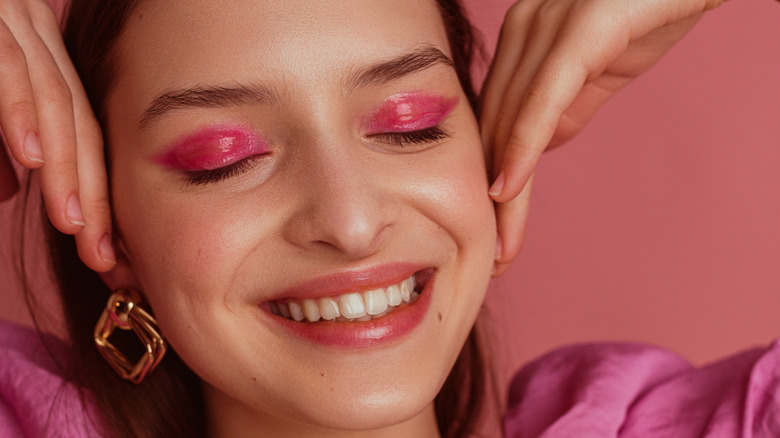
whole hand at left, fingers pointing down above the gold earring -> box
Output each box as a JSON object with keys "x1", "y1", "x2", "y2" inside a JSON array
[{"x1": 0, "y1": 0, "x2": 114, "y2": 271}]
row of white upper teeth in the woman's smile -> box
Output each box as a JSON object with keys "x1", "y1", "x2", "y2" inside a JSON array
[{"x1": 271, "y1": 276, "x2": 418, "y2": 322}]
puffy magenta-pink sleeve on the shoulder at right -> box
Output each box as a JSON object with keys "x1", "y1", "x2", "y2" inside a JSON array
[{"x1": 504, "y1": 342, "x2": 780, "y2": 438}]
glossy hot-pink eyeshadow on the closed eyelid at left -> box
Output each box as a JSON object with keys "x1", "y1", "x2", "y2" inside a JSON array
[{"x1": 155, "y1": 125, "x2": 270, "y2": 171}]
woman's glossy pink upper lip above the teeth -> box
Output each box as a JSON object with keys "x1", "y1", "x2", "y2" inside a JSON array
[{"x1": 268, "y1": 263, "x2": 425, "y2": 301}]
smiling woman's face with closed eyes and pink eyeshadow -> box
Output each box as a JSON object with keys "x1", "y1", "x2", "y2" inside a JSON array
[{"x1": 106, "y1": 0, "x2": 495, "y2": 436}]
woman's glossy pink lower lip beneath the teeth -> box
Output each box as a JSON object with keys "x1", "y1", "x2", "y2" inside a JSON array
[{"x1": 268, "y1": 278, "x2": 435, "y2": 349}]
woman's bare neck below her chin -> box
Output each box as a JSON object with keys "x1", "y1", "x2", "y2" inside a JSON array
[{"x1": 204, "y1": 385, "x2": 441, "y2": 438}]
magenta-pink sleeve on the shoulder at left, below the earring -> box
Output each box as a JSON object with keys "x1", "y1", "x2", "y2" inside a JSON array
[{"x1": 0, "y1": 320, "x2": 106, "y2": 437}]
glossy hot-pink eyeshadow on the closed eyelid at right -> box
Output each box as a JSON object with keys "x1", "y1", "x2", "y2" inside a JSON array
[{"x1": 364, "y1": 92, "x2": 458, "y2": 134}]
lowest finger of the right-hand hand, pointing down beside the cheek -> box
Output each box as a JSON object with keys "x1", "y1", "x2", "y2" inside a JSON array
[{"x1": 494, "y1": 173, "x2": 533, "y2": 276}]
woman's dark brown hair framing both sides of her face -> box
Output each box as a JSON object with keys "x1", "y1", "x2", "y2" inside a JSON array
[{"x1": 30, "y1": 0, "x2": 489, "y2": 438}]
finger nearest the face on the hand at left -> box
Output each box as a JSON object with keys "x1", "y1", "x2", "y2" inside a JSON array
[{"x1": 31, "y1": 7, "x2": 116, "y2": 272}]
